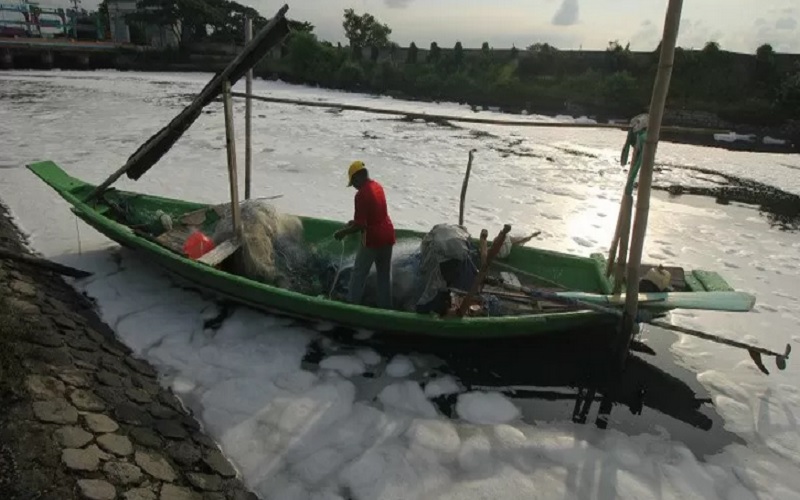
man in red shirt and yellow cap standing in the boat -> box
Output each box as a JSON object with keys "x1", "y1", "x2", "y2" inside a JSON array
[{"x1": 334, "y1": 161, "x2": 396, "y2": 309}]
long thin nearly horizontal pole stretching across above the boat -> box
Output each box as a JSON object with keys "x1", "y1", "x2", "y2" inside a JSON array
[{"x1": 228, "y1": 92, "x2": 729, "y2": 134}]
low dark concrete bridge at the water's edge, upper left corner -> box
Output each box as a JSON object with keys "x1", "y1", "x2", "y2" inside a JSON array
[{"x1": 0, "y1": 37, "x2": 155, "y2": 69}]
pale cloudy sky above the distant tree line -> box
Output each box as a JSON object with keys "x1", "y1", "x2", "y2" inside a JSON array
[{"x1": 54, "y1": 0, "x2": 800, "y2": 53}]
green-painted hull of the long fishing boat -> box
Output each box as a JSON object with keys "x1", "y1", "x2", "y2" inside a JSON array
[{"x1": 28, "y1": 161, "x2": 731, "y2": 339}]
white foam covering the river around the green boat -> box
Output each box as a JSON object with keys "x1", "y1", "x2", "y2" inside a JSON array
[{"x1": 0, "y1": 71, "x2": 800, "y2": 500}]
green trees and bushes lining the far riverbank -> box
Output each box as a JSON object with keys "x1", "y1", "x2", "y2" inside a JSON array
[{"x1": 125, "y1": 0, "x2": 800, "y2": 125}]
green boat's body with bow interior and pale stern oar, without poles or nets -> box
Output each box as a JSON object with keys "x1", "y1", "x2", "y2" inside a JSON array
[{"x1": 23, "y1": 161, "x2": 753, "y2": 339}]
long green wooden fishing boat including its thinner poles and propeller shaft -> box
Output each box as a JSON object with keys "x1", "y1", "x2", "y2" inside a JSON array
[{"x1": 20, "y1": 5, "x2": 791, "y2": 373}]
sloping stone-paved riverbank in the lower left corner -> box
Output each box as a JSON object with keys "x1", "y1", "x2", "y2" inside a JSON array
[{"x1": 0, "y1": 204, "x2": 257, "y2": 500}]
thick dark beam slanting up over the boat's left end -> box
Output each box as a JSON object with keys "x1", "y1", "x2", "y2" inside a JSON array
[{"x1": 84, "y1": 5, "x2": 290, "y2": 201}]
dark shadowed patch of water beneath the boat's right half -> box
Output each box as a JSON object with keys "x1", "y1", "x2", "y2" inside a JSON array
[{"x1": 305, "y1": 327, "x2": 743, "y2": 459}]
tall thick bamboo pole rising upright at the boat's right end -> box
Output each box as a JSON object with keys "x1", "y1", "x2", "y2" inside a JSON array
[{"x1": 618, "y1": 0, "x2": 683, "y2": 363}]
